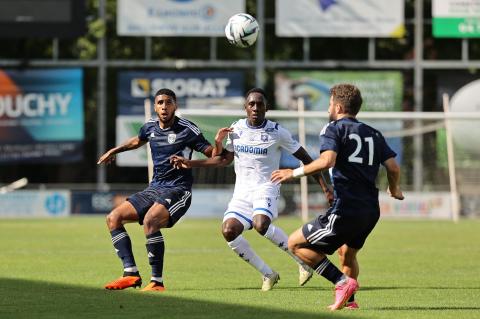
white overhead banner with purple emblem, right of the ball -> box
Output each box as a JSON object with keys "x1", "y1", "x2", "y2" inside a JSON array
[{"x1": 275, "y1": 0, "x2": 405, "y2": 38}]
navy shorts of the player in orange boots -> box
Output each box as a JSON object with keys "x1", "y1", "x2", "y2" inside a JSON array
[{"x1": 127, "y1": 186, "x2": 192, "y2": 227}]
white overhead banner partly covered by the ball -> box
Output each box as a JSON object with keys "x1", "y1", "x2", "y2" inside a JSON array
[{"x1": 117, "y1": 0, "x2": 245, "y2": 37}]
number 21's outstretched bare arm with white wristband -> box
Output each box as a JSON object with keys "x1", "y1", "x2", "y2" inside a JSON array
[{"x1": 271, "y1": 150, "x2": 337, "y2": 183}]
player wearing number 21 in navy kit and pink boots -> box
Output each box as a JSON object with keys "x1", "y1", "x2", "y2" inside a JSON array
[{"x1": 272, "y1": 84, "x2": 403, "y2": 310}]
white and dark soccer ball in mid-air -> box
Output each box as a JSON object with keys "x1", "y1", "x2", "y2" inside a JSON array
[{"x1": 225, "y1": 13, "x2": 260, "y2": 48}]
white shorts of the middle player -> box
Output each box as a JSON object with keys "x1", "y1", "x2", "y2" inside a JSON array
[{"x1": 223, "y1": 187, "x2": 280, "y2": 230}]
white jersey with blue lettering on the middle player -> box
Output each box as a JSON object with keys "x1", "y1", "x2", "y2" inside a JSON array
[{"x1": 225, "y1": 119, "x2": 300, "y2": 191}]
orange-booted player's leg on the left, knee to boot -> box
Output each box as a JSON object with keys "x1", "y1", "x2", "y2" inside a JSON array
[{"x1": 105, "y1": 201, "x2": 142, "y2": 290}]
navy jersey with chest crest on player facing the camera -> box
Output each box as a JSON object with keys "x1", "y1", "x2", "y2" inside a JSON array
[{"x1": 138, "y1": 116, "x2": 210, "y2": 189}]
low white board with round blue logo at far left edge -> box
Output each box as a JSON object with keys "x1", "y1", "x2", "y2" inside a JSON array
[{"x1": 0, "y1": 190, "x2": 70, "y2": 217}]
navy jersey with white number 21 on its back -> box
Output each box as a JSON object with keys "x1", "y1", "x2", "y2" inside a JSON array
[{"x1": 320, "y1": 117, "x2": 397, "y2": 203}]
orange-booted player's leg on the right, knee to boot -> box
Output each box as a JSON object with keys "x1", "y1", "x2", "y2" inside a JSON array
[{"x1": 142, "y1": 203, "x2": 170, "y2": 291}]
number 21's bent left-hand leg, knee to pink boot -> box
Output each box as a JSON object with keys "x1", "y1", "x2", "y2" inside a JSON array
[{"x1": 288, "y1": 229, "x2": 358, "y2": 310}]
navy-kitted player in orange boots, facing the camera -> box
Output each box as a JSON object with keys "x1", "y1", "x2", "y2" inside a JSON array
[{"x1": 97, "y1": 89, "x2": 213, "y2": 291}]
